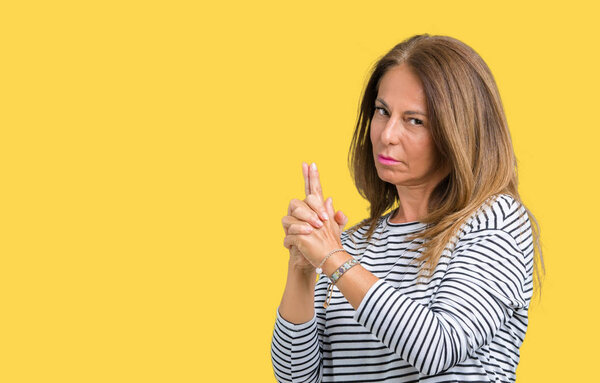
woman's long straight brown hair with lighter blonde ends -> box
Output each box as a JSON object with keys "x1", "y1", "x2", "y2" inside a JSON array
[{"x1": 348, "y1": 34, "x2": 544, "y2": 296}]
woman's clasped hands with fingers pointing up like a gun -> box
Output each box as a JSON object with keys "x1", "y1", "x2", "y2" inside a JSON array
[{"x1": 282, "y1": 163, "x2": 348, "y2": 271}]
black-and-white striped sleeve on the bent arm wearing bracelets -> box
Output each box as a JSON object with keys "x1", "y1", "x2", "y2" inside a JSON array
[{"x1": 354, "y1": 229, "x2": 530, "y2": 375}]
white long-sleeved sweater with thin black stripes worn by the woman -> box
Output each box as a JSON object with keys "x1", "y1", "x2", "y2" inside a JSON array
[{"x1": 271, "y1": 194, "x2": 533, "y2": 382}]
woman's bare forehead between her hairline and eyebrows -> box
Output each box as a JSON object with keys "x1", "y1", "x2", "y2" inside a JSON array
[{"x1": 377, "y1": 64, "x2": 426, "y2": 110}]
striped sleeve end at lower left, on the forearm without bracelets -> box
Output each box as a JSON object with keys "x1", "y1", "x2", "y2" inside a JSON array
[{"x1": 271, "y1": 308, "x2": 322, "y2": 382}]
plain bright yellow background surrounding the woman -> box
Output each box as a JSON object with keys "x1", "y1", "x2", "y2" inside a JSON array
[{"x1": 0, "y1": 1, "x2": 600, "y2": 383}]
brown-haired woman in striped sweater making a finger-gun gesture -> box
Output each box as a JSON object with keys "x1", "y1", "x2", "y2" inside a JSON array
[{"x1": 271, "y1": 35, "x2": 541, "y2": 382}]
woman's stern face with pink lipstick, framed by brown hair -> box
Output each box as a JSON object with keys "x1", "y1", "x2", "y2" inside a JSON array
[{"x1": 370, "y1": 64, "x2": 447, "y2": 191}]
